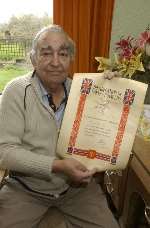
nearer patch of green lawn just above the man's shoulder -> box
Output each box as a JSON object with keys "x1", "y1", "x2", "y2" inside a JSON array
[{"x1": 0, "y1": 65, "x2": 30, "y2": 92}]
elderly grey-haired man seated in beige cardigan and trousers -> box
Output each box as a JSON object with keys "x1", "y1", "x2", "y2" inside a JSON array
[{"x1": 0, "y1": 25, "x2": 118, "y2": 228}]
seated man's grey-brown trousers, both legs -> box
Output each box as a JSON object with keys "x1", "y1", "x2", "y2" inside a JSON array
[{"x1": 0, "y1": 181, "x2": 119, "y2": 228}]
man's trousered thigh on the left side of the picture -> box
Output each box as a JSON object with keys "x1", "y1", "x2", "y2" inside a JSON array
[{"x1": 0, "y1": 184, "x2": 47, "y2": 228}]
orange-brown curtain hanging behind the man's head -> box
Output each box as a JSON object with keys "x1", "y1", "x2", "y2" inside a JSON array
[{"x1": 53, "y1": 0, "x2": 115, "y2": 73}]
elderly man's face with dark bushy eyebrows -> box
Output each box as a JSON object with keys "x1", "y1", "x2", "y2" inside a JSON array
[{"x1": 33, "y1": 32, "x2": 71, "y2": 87}]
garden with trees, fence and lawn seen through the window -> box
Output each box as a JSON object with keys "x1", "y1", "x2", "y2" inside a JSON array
[{"x1": 0, "y1": 14, "x2": 52, "y2": 92}]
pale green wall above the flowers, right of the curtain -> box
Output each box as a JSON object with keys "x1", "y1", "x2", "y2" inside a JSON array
[{"x1": 110, "y1": 0, "x2": 150, "y2": 55}]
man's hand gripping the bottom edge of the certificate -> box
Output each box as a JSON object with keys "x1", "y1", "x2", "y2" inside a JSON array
[{"x1": 52, "y1": 158, "x2": 96, "y2": 183}]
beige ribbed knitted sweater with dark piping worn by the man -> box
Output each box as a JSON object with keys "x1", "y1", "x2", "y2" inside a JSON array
[{"x1": 0, "y1": 74, "x2": 71, "y2": 194}]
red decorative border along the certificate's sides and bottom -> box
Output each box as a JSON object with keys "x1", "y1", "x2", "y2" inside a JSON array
[{"x1": 67, "y1": 78, "x2": 135, "y2": 165}]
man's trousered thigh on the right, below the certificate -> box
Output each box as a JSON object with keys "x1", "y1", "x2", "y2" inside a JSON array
[{"x1": 60, "y1": 181, "x2": 119, "y2": 228}]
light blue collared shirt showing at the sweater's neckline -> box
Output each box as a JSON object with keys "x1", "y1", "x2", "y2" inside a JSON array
[{"x1": 37, "y1": 77, "x2": 66, "y2": 128}]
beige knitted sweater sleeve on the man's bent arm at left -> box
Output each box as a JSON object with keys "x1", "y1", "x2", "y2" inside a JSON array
[{"x1": 0, "y1": 79, "x2": 55, "y2": 180}]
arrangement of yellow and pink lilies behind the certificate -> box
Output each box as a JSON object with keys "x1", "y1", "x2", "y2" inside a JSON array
[{"x1": 95, "y1": 27, "x2": 150, "y2": 78}]
